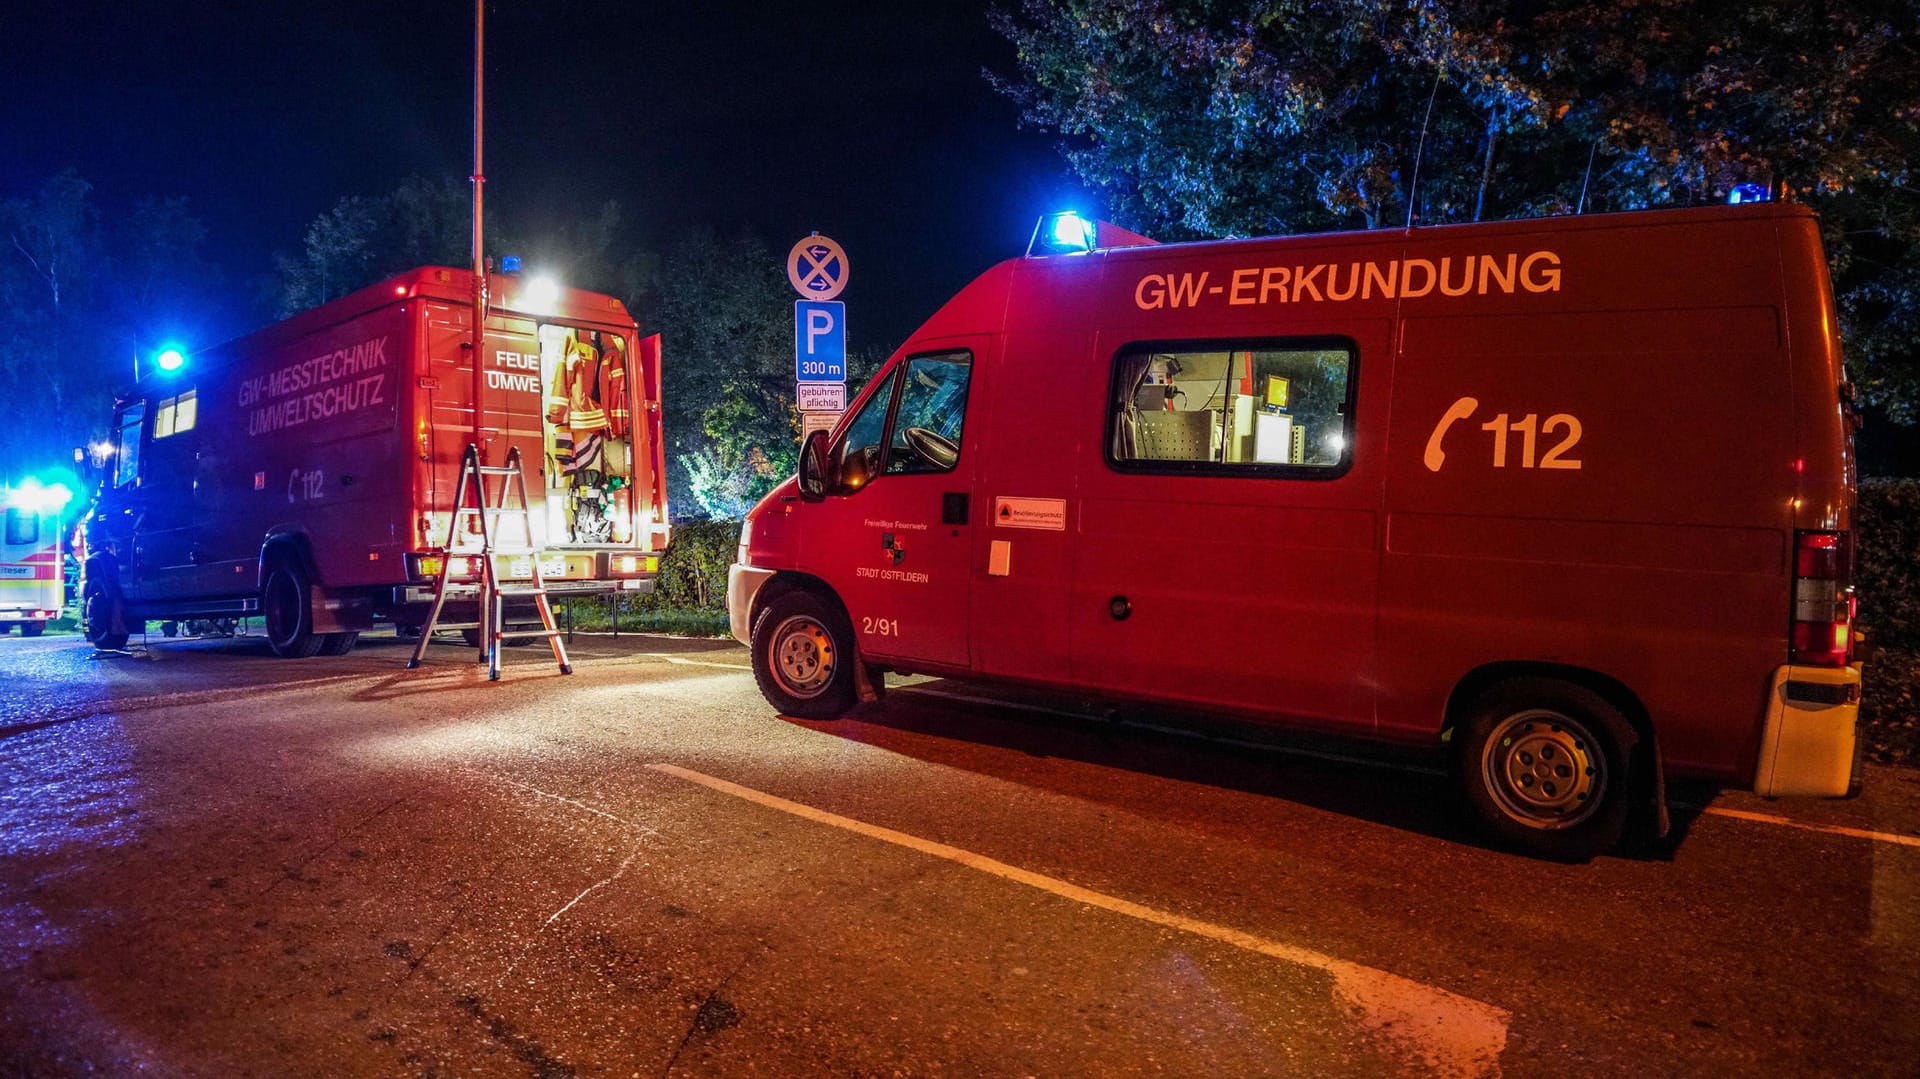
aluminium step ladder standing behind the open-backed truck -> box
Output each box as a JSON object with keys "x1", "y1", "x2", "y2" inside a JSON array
[{"x1": 407, "y1": 444, "x2": 574, "y2": 682}]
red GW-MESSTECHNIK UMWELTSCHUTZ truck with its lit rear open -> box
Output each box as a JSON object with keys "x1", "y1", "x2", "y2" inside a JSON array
[{"x1": 81, "y1": 267, "x2": 668, "y2": 657}]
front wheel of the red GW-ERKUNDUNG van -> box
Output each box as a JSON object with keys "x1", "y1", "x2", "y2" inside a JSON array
[{"x1": 753, "y1": 591, "x2": 856, "y2": 720}]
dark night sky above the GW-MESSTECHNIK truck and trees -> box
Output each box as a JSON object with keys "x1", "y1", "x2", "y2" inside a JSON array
[{"x1": 0, "y1": 0, "x2": 1098, "y2": 348}]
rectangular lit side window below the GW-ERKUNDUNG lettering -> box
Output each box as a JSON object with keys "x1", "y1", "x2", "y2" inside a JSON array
[{"x1": 1108, "y1": 340, "x2": 1354, "y2": 476}]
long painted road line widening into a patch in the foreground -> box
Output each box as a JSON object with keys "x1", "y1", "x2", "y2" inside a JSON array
[{"x1": 647, "y1": 762, "x2": 1511, "y2": 1075}]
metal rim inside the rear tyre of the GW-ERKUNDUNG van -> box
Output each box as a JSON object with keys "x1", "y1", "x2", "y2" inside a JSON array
[{"x1": 1480, "y1": 710, "x2": 1607, "y2": 827}]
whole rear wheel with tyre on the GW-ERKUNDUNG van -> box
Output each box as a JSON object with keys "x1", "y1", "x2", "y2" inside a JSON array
[{"x1": 1457, "y1": 678, "x2": 1638, "y2": 862}]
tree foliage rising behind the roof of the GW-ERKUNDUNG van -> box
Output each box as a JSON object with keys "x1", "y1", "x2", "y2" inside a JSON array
[{"x1": 989, "y1": 0, "x2": 1920, "y2": 408}]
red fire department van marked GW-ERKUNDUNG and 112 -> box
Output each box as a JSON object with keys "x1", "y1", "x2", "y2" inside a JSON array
[{"x1": 728, "y1": 204, "x2": 1860, "y2": 856}]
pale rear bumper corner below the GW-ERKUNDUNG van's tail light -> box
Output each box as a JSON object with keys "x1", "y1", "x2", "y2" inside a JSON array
[{"x1": 1753, "y1": 664, "x2": 1860, "y2": 799}]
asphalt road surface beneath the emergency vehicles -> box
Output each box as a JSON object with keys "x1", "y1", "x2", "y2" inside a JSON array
[{"x1": 0, "y1": 635, "x2": 1920, "y2": 1077}]
